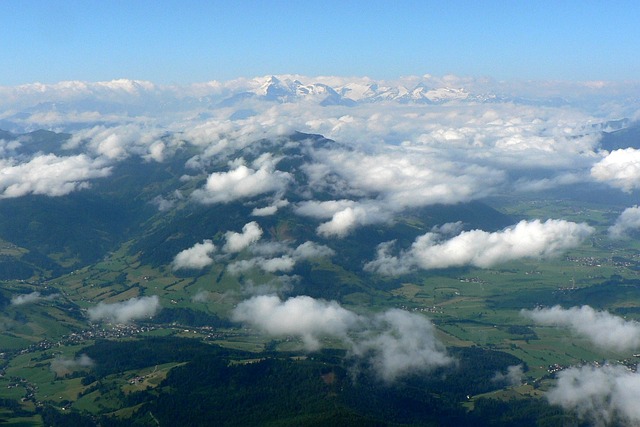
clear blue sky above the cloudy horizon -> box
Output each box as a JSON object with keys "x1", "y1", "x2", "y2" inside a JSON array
[{"x1": 0, "y1": 0, "x2": 640, "y2": 86}]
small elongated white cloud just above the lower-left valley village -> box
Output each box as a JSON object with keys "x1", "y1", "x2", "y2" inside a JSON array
[{"x1": 87, "y1": 295, "x2": 161, "y2": 323}]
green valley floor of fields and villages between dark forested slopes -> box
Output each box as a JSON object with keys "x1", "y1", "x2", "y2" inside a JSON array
[{"x1": 0, "y1": 184, "x2": 640, "y2": 425}]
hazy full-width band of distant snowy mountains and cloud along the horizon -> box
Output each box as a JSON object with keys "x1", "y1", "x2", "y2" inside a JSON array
[{"x1": 0, "y1": 75, "x2": 640, "y2": 133}]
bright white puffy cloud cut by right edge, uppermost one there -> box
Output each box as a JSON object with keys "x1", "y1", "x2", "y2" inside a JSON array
[{"x1": 591, "y1": 148, "x2": 640, "y2": 192}]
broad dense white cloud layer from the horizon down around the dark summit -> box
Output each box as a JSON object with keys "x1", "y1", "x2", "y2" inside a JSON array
[{"x1": 0, "y1": 75, "x2": 638, "y2": 238}]
